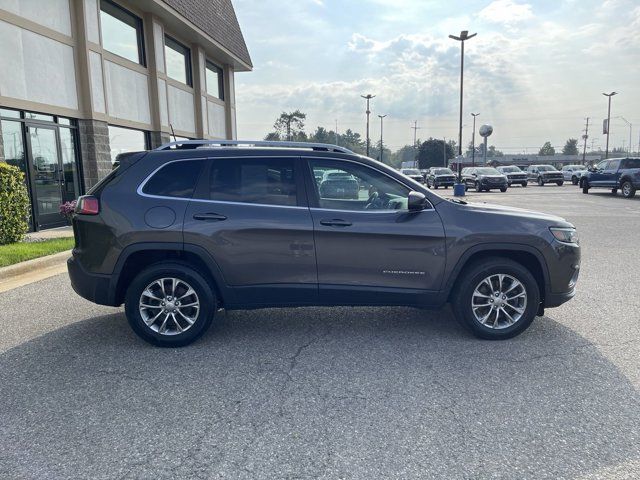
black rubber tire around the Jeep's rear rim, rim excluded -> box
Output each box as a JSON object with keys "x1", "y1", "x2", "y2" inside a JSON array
[{"x1": 125, "y1": 262, "x2": 217, "y2": 347}]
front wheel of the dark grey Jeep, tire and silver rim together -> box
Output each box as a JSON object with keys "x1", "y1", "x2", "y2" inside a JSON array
[{"x1": 452, "y1": 257, "x2": 540, "y2": 340}]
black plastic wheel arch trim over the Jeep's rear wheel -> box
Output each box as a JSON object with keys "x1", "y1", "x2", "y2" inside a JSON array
[{"x1": 109, "y1": 242, "x2": 233, "y2": 305}]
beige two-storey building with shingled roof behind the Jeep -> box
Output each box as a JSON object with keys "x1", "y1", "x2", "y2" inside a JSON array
[{"x1": 0, "y1": 0, "x2": 252, "y2": 230}]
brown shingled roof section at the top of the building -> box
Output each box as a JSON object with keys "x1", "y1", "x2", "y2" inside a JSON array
[{"x1": 163, "y1": 0, "x2": 253, "y2": 67}]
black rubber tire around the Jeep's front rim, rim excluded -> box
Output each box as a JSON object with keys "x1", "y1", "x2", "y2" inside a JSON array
[{"x1": 452, "y1": 257, "x2": 540, "y2": 340}]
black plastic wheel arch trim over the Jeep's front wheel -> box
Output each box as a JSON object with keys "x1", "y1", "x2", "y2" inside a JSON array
[{"x1": 445, "y1": 244, "x2": 549, "y2": 304}]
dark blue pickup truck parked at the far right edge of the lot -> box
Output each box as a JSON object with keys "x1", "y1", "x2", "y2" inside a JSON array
[{"x1": 580, "y1": 158, "x2": 640, "y2": 198}]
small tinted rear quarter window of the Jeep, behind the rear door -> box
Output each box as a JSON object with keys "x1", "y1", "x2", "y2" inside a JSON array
[{"x1": 142, "y1": 160, "x2": 202, "y2": 198}]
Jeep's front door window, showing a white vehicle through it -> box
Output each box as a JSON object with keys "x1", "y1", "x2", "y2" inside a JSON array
[{"x1": 310, "y1": 160, "x2": 411, "y2": 211}]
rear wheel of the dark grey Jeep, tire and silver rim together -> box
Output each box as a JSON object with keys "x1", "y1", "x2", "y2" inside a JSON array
[{"x1": 125, "y1": 262, "x2": 216, "y2": 347}]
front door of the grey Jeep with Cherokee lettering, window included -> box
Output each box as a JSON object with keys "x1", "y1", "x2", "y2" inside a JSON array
[{"x1": 305, "y1": 158, "x2": 445, "y2": 304}]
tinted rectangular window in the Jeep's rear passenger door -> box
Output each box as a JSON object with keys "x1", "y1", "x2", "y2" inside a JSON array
[{"x1": 209, "y1": 158, "x2": 298, "y2": 206}]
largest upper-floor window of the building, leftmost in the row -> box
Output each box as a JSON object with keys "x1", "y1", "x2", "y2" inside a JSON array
[{"x1": 100, "y1": 0, "x2": 145, "y2": 65}]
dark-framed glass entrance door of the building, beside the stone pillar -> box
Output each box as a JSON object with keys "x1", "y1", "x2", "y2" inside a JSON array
[{"x1": 26, "y1": 124, "x2": 66, "y2": 230}]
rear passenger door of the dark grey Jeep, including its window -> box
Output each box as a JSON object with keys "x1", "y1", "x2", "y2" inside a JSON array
[{"x1": 184, "y1": 156, "x2": 317, "y2": 305}]
